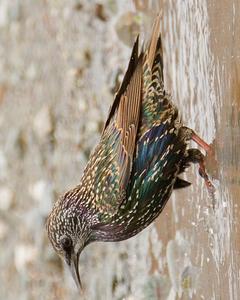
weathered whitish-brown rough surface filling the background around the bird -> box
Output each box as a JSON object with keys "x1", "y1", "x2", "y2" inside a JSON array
[{"x1": 0, "y1": 0, "x2": 240, "y2": 300}]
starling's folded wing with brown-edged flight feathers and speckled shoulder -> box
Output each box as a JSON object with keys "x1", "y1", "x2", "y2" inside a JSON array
[{"x1": 85, "y1": 38, "x2": 143, "y2": 218}]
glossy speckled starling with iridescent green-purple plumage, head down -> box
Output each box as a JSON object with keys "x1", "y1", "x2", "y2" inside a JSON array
[{"x1": 47, "y1": 17, "x2": 213, "y2": 286}]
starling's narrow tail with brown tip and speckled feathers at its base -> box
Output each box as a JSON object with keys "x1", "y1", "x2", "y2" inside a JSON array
[{"x1": 139, "y1": 15, "x2": 177, "y2": 136}]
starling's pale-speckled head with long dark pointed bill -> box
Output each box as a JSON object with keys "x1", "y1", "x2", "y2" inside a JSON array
[{"x1": 46, "y1": 196, "x2": 90, "y2": 289}]
